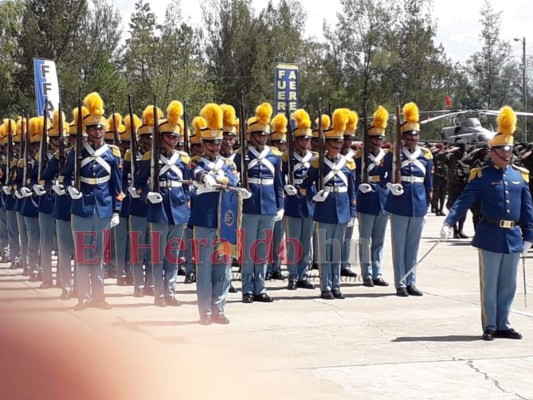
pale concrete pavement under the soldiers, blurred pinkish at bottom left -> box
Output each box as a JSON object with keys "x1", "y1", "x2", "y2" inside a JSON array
[{"x1": 0, "y1": 215, "x2": 533, "y2": 399}]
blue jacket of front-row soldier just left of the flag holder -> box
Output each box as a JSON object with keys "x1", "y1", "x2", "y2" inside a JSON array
[{"x1": 135, "y1": 150, "x2": 190, "y2": 225}]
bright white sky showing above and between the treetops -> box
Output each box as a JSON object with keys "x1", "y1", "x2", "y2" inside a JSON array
[{"x1": 114, "y1": 0, "x2": 533, "y2": 63}]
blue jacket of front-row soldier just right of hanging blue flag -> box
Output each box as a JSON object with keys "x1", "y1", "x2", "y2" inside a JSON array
[{"x1": 234, "y1": 146, "x2": 283, "y2": 215}]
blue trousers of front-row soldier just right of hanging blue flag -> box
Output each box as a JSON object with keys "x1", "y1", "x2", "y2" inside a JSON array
[{"x1": 241, "y1": 214, "x2": 275, "y2": 295}]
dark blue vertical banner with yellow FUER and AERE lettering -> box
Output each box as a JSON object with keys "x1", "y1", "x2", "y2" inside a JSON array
[{"x1": 274, "y1": 64, "x2": 300, "y2": 115}]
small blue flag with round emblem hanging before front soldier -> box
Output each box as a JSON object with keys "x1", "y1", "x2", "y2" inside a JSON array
[{"x1": 217, "y1": 190, "x2": 242, "y2": 250}]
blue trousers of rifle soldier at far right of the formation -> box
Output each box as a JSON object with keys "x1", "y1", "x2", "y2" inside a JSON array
[{"x1": 390, "y1": 214, "x2": 424, "y2": 289}]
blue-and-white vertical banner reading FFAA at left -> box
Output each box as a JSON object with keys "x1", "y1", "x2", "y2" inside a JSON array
[{"x1": 33, "y1": 58, "x2": 59, "y2": 118}]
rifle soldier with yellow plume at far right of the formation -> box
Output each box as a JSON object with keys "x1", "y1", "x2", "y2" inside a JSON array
[{"x1": 385, "y1": 103, "x2": 433, "y2": 297}]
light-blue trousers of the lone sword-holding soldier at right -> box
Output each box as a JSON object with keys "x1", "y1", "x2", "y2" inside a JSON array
[{"x1": 479, "y1": 249, "x2": 520, "y2": 330}]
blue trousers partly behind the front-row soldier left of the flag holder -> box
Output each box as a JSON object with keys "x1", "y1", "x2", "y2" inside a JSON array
[{"x1": 130, "y1": 215, "x2": 155, "y2": 288}]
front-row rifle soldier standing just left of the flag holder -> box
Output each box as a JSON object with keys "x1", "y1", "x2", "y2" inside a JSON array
[{"x1": 135, "y1": 101, "x2": 190, "y2": 307}]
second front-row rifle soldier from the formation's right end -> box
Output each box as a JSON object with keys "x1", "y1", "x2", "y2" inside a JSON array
[{"x1": 300, "y1": 109, "x2": 356, "y2": 300}]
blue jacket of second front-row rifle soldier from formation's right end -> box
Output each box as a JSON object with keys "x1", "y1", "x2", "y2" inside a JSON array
[{"x1": 302, "y1": 156, "x2": 356, "y2": 224}]
